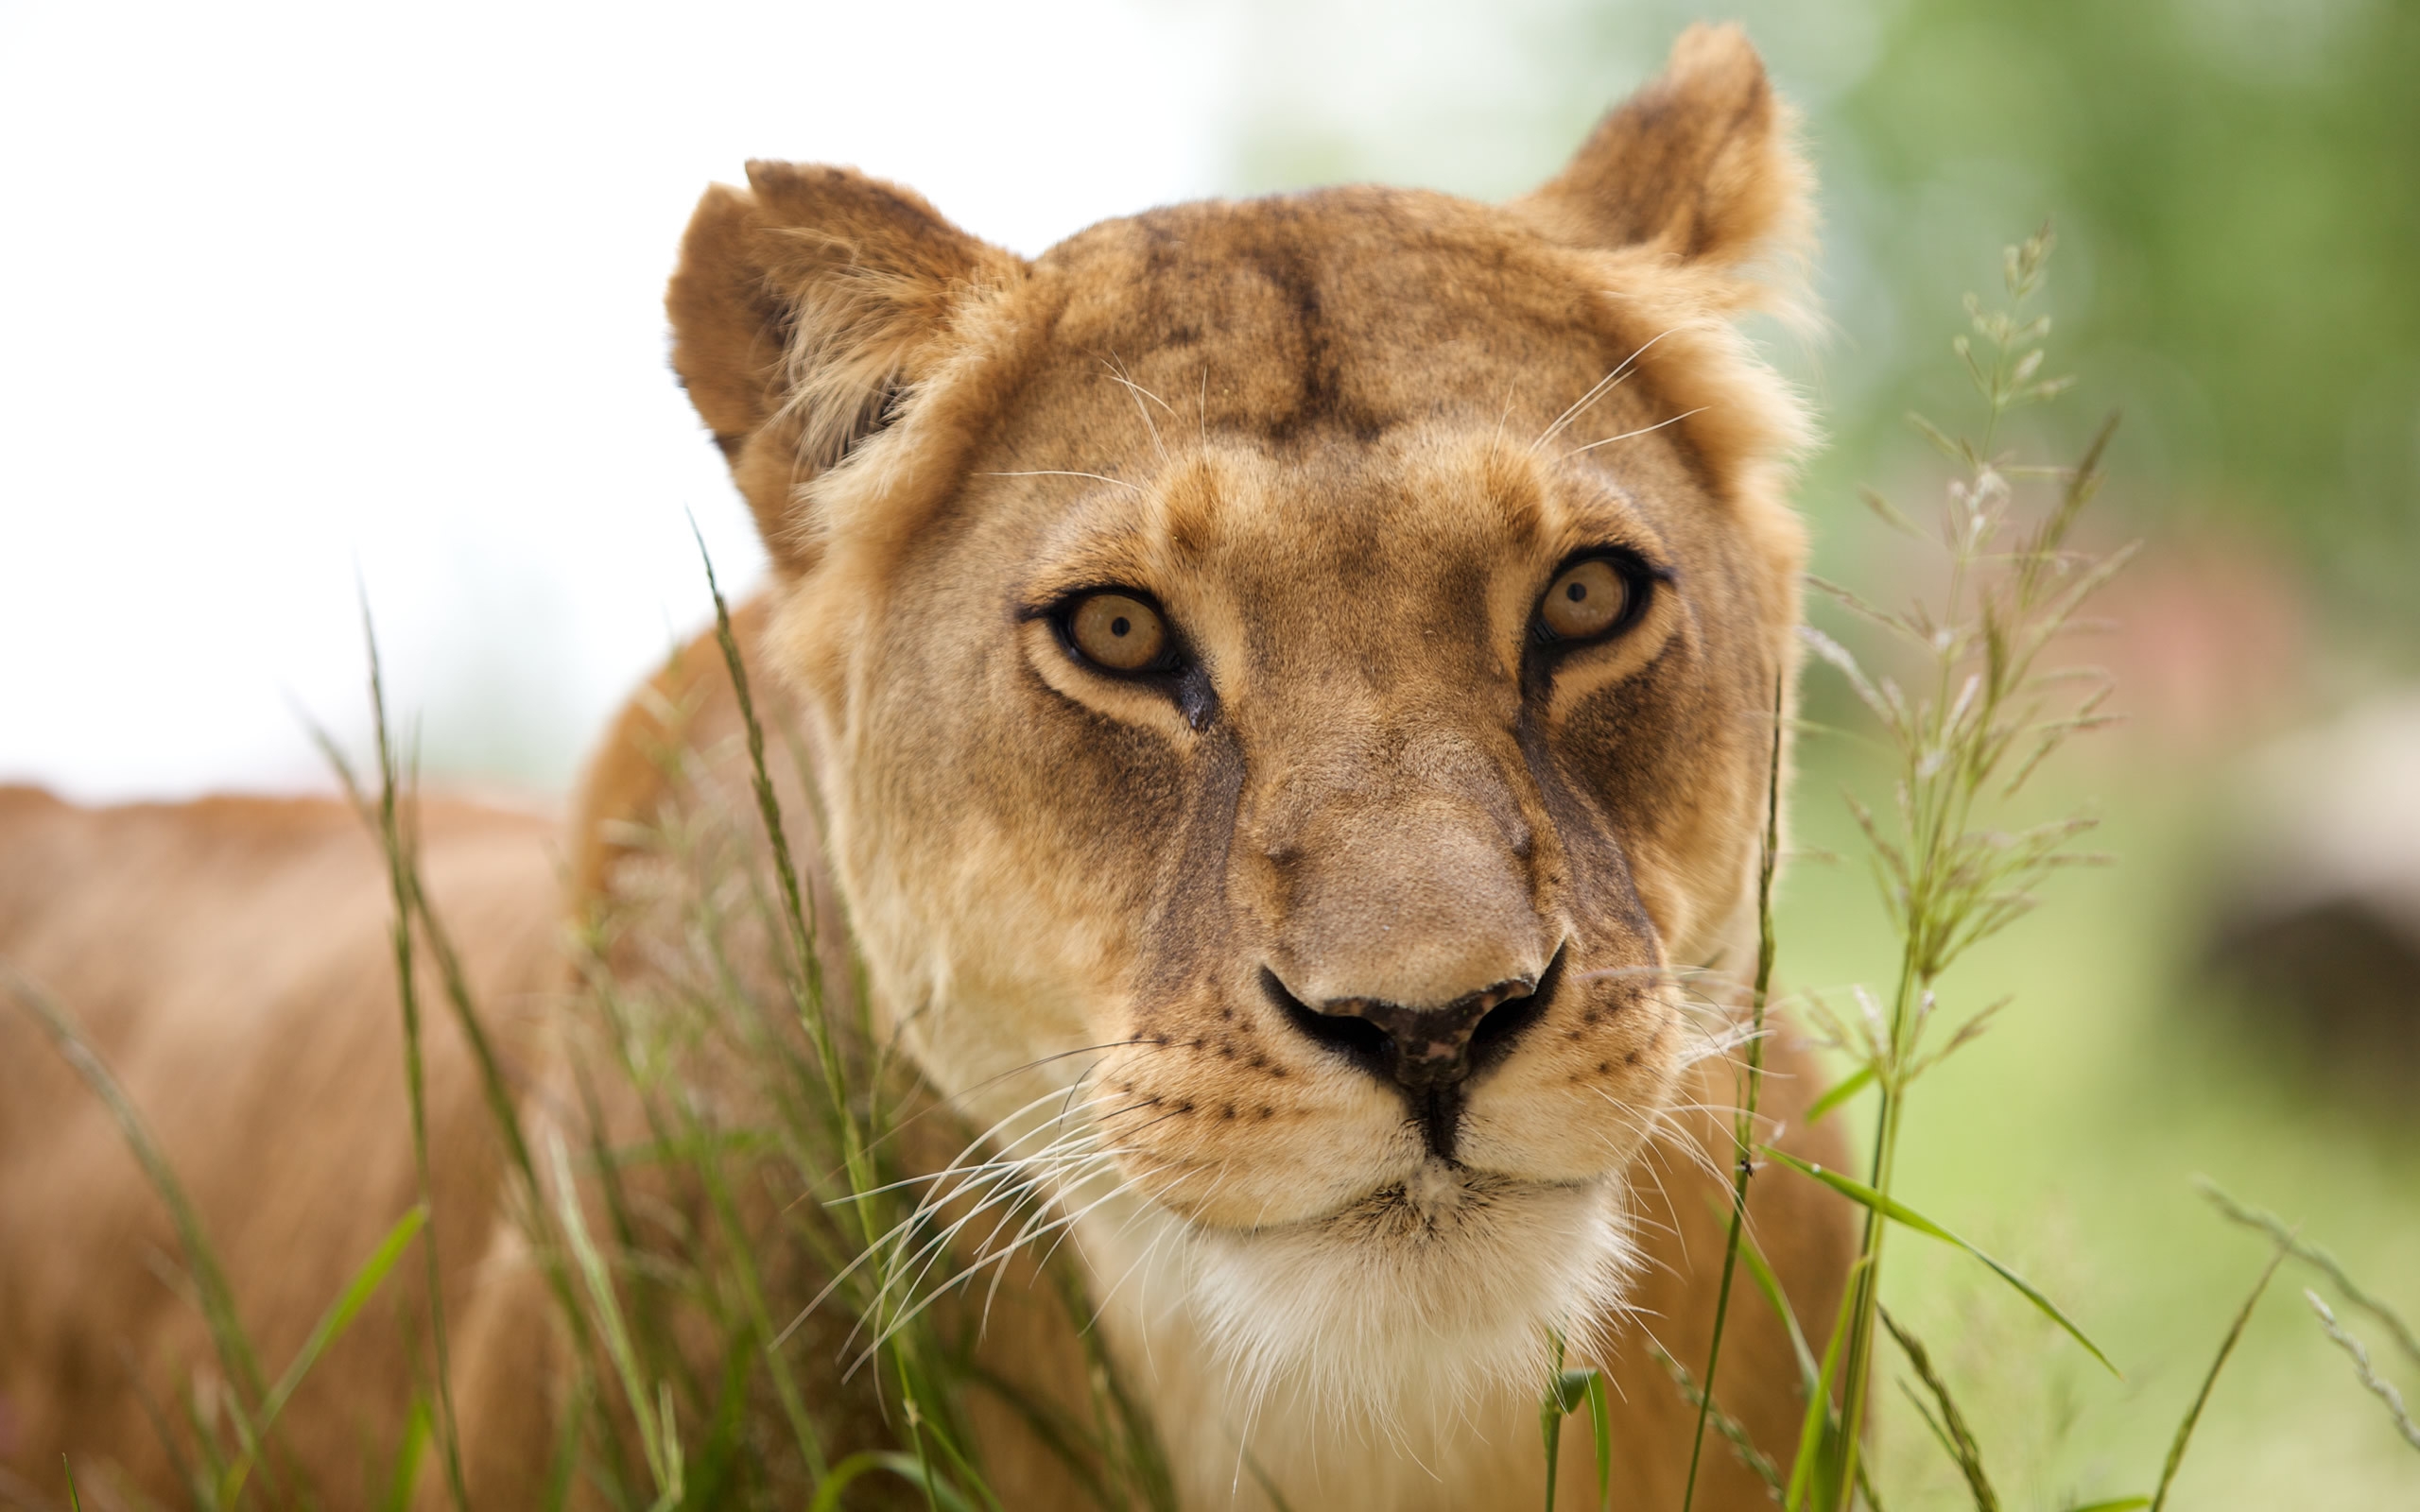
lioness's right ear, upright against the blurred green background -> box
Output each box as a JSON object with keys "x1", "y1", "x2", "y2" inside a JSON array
[{"x1": 1510, "y1": 25, "x2": 1807, "y2": 277}]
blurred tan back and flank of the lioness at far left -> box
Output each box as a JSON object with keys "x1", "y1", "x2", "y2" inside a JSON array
[{"x1": 0, "y1": 789, "x2": 566, "y2": 1504}]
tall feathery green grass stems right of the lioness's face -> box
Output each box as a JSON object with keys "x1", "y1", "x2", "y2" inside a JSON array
[{"x1": 1626, "y1": 230, "x2": 2420, "y2": 1512}]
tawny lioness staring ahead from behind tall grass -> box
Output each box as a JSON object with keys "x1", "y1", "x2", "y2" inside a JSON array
[{"x1": 0, "y1": 29, "x2": 1849, "y2": 1509}]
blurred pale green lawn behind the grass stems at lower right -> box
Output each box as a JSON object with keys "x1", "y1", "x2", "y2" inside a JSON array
[{"x1": 1779, "y1": 730, "x2": 2420, "y2": 1509}]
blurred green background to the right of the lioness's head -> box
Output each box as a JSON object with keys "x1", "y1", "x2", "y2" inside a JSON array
[{"x1": 1235, "y1": 0, "x2": 2420, "y2": 1509}]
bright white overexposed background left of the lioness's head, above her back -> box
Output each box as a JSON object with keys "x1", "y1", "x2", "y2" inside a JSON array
[{"x1": 0, "y1": 0, "x2": 1232, "y2": 799}]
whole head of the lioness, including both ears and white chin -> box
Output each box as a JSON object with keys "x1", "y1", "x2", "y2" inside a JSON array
[{"x1": 670, "y1": 29, "x2": 1803, "y2": 1413}]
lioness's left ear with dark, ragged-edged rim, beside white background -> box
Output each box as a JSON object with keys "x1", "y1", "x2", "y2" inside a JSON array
[{"x1": 663, "y1": 163, "x2": 1024, "y2": 569}]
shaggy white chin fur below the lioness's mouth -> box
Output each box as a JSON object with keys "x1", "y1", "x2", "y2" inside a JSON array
[{"x1": 1185, "y1": 1161, "x2": 1636, "y2": 1439}]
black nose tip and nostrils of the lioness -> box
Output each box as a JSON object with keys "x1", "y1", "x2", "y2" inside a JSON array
[{"x1": 1261, "y1": 951, "x2": 1564, "y2": 1157}]
